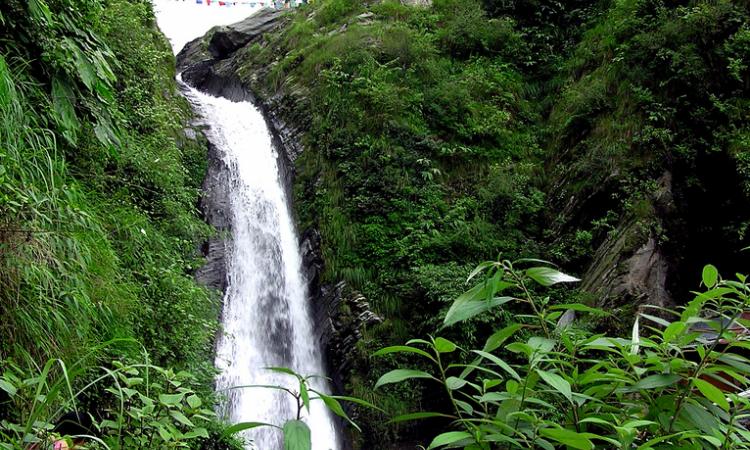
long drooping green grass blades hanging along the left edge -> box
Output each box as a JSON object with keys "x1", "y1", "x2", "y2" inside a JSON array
[{"x1": 0, "y1": 56, "x2": 125, "y2": 368}]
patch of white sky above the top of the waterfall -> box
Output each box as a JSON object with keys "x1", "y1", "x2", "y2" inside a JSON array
[{"x1": 152, "y1": 0, "x2": 260, "y2": 54}]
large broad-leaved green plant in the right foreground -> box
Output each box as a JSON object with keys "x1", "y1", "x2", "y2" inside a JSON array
[{"x1": 376, "y1": 261, "x2": 750, "y2": 450}]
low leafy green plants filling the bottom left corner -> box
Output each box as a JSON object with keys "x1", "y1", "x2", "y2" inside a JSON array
[{"x1": 0, "y1": 352, "x2": 241, "y2": 450}]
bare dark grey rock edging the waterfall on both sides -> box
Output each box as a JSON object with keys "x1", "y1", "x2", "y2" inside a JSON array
[{"x1": 177, "y1": 8, "x2": 380, "y2": 408}]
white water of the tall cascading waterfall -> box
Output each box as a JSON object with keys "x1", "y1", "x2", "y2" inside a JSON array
[{"x1": 178, "y1": 83, "x2": 339, "y2": 450}]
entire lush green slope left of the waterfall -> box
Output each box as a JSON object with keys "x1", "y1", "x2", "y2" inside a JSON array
[{"x1": 0, "y1": 0, "x2": 239, "y2": 448}]
